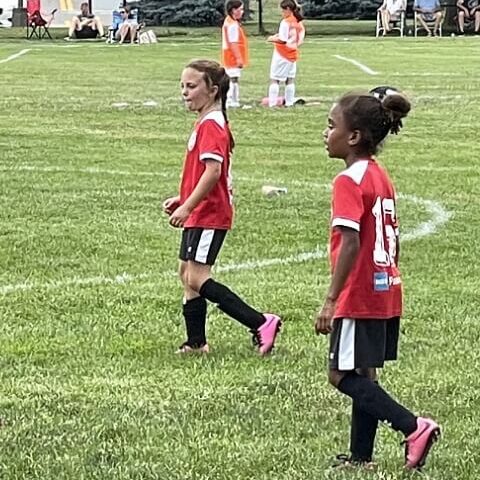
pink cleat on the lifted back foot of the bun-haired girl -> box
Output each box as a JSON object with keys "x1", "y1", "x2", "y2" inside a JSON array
[{"x1": 403, "y1": 417, "x2": 440, "y2": 469}]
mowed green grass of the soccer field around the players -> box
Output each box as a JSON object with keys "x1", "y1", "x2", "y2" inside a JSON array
[{"x1": 0, "y1": 32, "x2": 480, "y2": 480}]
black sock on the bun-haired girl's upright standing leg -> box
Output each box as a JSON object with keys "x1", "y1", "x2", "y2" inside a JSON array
[{"x1": 350, "y1": 401, "x2": 378, "y2": 462}]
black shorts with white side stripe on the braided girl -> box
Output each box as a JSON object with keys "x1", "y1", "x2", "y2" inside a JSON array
[{"x1": 179, "y1": 228, "x2": 228, "y2": 265}]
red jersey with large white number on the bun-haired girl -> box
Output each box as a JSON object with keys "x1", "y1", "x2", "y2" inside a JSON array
[{"x1": 330, "y1": 159, "x2": 402, "y2": 319}]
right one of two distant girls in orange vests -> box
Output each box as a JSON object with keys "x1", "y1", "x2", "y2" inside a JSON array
[{"x1": 268, "y1": 0, "x2": 305, "y2": 107}]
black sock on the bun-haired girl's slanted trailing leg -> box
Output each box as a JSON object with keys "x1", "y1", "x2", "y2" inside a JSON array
[{"x1": 338, "y1": 372, "x2": 417, "y2": 436}]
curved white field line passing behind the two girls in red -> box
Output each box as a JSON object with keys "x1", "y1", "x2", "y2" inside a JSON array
[{"x1": 0, "y1": 186, "x2": 452, "y2": 295}]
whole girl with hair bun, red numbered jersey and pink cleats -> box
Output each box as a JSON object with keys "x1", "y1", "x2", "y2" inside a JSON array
[{"x1": 315, "y1": 89, "x2": 440, "y2": 469}]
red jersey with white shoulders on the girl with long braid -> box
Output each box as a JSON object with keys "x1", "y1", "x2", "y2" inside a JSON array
[{"x1": 180, "y1": 111, "x2": 233, "y2": 230}]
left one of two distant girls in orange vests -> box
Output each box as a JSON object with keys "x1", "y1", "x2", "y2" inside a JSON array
[{"x1": 222, "y1": 0, "x2": 248, "y2": 107}]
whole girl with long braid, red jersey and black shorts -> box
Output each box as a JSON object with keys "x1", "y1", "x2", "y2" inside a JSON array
[{"x1": 163, "y1": 60, "x2": 281, "y2": 355}]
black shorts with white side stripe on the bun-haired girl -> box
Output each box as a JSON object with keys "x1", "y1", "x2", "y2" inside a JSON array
[{"x1": 328, "y1": 317, "x2": 400, "y2": 371}]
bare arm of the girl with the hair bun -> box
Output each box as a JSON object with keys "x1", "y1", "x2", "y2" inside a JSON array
[{"x1": 315, "y1": 227, "x2": 360, "y2": 335}]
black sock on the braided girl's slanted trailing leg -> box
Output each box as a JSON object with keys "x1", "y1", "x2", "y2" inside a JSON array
[{"x1": 199, "y1": 278, "x2": 265, "y2": 331}]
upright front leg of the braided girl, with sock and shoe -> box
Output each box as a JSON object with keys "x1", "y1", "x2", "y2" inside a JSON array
[{"x1": 179, "y1": 260, "x2": 208, "y2": 353}]
